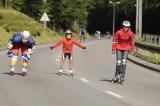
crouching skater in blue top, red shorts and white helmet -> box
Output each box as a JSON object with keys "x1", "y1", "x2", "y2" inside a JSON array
[{"x1": 7, "y1": 31, "x2": 35, "y2": 76}]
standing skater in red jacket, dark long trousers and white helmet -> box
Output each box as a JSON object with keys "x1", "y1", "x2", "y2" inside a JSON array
[{"x1": 112, "y1": 21, "x2": 135, "y2": 83}]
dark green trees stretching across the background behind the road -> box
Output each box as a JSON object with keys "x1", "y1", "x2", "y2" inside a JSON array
[{"x1": 0, "y1": 0, "x2": 160, "y2": 33}]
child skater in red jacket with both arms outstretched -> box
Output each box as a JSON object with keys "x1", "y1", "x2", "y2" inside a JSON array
[{"x1": 50, "y1": 30, "x2": 86, "y2": 76}]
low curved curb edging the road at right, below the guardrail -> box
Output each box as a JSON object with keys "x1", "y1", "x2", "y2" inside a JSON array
[{"x1": 128, "y1": 56, "x2": 160, "y2": 73}]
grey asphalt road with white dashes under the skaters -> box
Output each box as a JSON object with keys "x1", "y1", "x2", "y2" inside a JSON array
[{"x1": 0, "y1": 40, "x2": 160, "y2": 106}]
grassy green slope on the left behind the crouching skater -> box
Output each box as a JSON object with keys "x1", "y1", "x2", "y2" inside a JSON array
[{"x1": 0, "y1": 8, "x2": 61, "y2": 47}]
